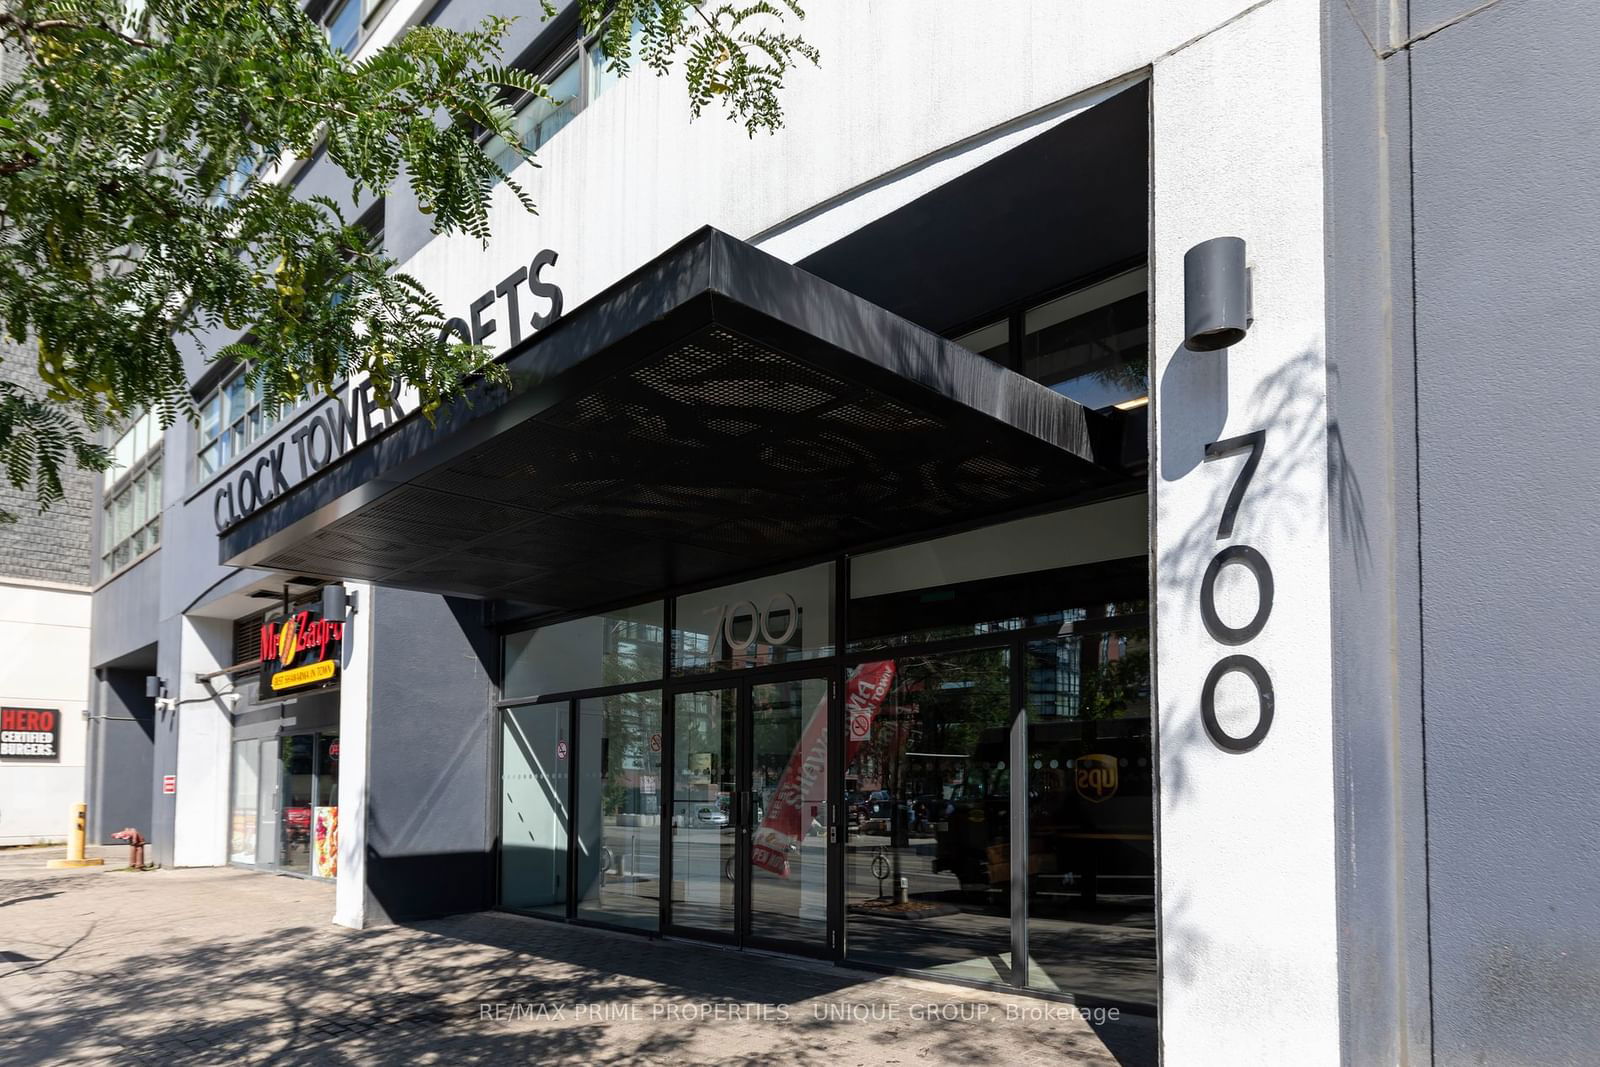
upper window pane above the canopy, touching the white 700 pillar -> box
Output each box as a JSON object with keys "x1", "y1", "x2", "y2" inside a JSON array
[{"x1": 1022, "y1": 267, "x2": 1150, "y2": 408}]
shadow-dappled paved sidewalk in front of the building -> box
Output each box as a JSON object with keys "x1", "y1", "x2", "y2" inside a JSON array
[{"x1": 0, "y1": 854, "x2": 1155, "y2": 1067}]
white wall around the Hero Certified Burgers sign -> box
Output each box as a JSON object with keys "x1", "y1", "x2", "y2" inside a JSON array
[{"x1": 0, "y1": 579, "x2": 90, "y2": 845}]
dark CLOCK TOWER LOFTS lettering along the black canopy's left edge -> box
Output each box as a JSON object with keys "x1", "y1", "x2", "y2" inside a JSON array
[{"x1": 211, "y1": 248, "x2": 562, "y2": 530}]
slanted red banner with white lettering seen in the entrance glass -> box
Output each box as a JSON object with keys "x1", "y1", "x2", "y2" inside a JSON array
[{"x1": 750, "y1": 659, "x2": 894, "y2": 878}]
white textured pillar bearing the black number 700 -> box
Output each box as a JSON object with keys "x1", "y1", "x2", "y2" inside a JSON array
[{"x1": 1152, "y1": 0, "x2": 1339, "y2": 1065}]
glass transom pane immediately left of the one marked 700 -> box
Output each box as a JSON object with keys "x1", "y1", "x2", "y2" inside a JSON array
[{"x1": 504, "y1": 600, "x2": 664, "y2": 699}]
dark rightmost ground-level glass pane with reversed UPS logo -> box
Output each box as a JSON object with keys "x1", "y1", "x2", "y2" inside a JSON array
[{"x1": 1027, "y1": 627, "x2": 1155, "y2": 1005}]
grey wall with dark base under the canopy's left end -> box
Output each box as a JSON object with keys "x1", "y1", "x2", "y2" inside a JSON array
[{"x1": 366, "y1": 589, "x2": 498, "y2": 920}]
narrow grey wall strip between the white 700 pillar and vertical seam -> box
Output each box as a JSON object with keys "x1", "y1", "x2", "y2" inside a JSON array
[{"x1": 1323, "y1": 0, "x2": 1429, "y2": 1064}]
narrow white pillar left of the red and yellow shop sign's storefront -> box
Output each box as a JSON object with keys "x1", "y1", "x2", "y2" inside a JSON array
[{"x1": 166, "y1": 616, "x2": 234, "y2": 867}]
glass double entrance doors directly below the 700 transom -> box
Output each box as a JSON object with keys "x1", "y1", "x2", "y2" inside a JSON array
[{"x1": 670, "y1": 675, "x2": 830, "y2": 955}]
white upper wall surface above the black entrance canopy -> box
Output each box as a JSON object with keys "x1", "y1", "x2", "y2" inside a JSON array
[{"x1": 386, "y1": 0, "x2": 1286, "y2": 335}]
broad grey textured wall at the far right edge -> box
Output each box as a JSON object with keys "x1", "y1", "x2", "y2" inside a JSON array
[{"x1": 1411, "y1": 0, "x2": 1600, "y2": 1064}]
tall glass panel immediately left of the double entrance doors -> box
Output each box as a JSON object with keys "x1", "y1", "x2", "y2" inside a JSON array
[{"x1": 576, "y1": 693, "x2": 661, "y2": 929}]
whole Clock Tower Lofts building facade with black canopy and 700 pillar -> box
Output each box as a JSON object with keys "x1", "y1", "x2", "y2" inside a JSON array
[{"x1": 78, "y1": 0, "x2": 1600, "y2": 1064}]
